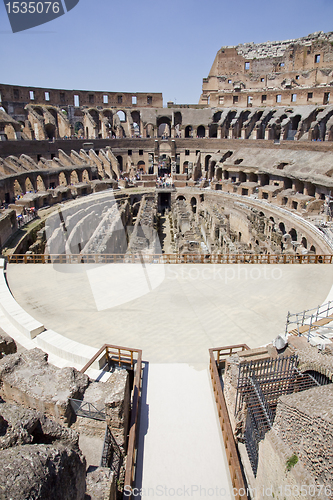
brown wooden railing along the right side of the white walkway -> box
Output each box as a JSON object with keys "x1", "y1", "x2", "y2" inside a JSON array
[{"x1": 209, "y1": 344, "x2": 248, "y2": 500}]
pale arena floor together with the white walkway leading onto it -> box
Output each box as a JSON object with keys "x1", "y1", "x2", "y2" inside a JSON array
[{"x1": 4, "y1": 264, "x2": 333, "y2": 500}]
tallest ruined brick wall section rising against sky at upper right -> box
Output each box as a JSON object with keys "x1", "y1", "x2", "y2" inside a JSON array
[{"x1": 199, "y1": 31, "x2": 333, "y2": 108}]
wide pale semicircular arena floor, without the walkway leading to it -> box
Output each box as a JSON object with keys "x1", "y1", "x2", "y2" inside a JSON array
[{"x1": 7, "y1": 264, "x2": 333, "y2": 365}]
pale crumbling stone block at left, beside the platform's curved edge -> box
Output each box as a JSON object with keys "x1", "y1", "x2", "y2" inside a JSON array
[{"x1": 0, "y1": 349, "x2": 89, "y2": 423}]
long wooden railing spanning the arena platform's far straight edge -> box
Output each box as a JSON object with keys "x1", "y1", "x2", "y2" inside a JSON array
[{"x1": 6, "y1": 253, "x2": 333, "y2": 264}]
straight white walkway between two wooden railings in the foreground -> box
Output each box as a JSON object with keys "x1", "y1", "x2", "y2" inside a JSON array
[{"x1": 134, "y1": 363, "x2": 234, "y2": 500}]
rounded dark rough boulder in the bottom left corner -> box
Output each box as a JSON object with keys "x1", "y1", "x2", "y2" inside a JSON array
[{"x1": 0, "y1": 443, "x2": 86, "y2": 500}]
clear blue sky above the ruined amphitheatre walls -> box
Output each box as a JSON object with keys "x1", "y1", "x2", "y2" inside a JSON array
[{"x1": 0, "y1": 0, "x2": 333, "y2": 104}]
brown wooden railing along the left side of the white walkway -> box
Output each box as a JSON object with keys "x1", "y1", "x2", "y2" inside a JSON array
[{"x1": 81, "y1": 344, "x2": 142, "y2": 499}]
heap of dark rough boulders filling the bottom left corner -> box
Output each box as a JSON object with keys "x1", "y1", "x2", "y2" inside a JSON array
[{"x1": 0, "y1": 403, "x2": 86, "y2": 500}]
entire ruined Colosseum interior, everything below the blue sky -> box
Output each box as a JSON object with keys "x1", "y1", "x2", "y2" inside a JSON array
[{"x1": 0, "y1": 32, "x2": 333, "y2": 500}]
